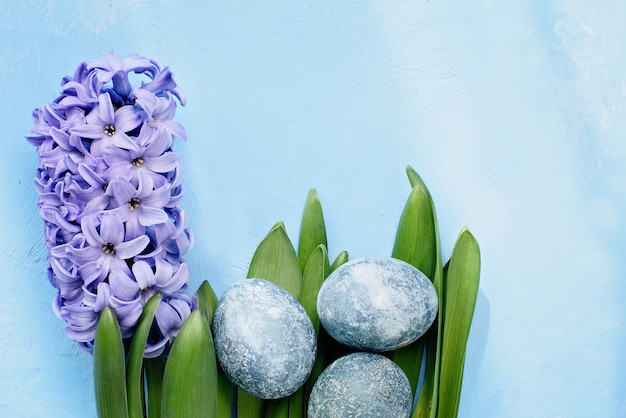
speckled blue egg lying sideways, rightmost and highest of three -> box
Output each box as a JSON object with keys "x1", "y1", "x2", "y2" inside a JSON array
[{"x1": 317, "y1": 257, "x2": 439, "y2": 351}]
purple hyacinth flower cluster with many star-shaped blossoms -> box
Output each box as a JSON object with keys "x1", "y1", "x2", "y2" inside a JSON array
[{"x1": 26, "y1": 52, "x2": 193, "y2": 357}]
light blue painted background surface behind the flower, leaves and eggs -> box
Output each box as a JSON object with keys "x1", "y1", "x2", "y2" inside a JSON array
[{"x1": 0, "y1": 0, "x2": 626, "y2": 418}]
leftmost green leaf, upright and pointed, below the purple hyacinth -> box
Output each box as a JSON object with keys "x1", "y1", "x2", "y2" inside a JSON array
[{"x1": 93, "y1": 306, "x2": 128, "y2": 418}]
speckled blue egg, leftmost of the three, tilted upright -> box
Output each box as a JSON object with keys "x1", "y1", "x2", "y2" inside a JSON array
[{"x1": 213, "y1": 279, "x2": 317, "y2": 399}]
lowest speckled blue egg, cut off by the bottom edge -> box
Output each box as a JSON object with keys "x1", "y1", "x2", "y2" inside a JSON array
[{"x1": 308, "y1": 353, "x2": 413, "y2": 418}]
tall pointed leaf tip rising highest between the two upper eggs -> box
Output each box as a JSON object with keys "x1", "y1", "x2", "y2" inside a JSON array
[{"x1": 298, "y1": 189, "x2": 328, "y2": 271}]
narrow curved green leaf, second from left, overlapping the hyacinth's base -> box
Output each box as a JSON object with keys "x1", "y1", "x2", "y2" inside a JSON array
[{"x1": 126, "y1": 293, "x2": 162, "y2": 418}]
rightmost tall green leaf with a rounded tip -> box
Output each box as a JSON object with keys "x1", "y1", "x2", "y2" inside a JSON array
[{"x1": 437, "y1": 228, "x2": 480, "y2": 418}]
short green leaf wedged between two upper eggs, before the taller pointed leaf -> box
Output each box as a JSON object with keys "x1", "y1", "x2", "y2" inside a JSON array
[{"x1": 298, "y1": 244, "x2": 330, "y2": 333}]
